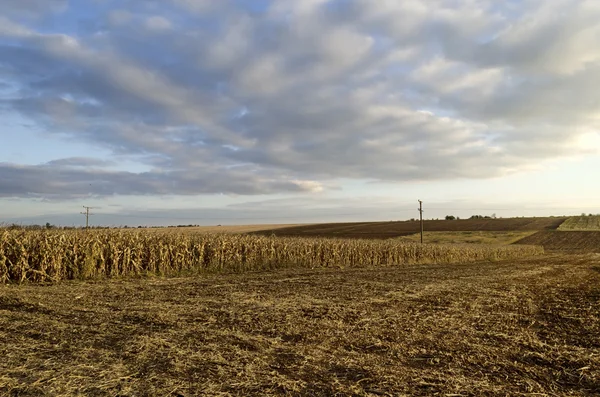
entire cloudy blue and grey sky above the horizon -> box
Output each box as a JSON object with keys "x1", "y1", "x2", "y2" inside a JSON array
[{"x1": 0, "y1": 0, "x2": 600, "y2": 226}]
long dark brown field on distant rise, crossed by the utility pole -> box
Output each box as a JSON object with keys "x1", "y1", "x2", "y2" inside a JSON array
[{"x1": 256, "y1": 217, "x2": 566, "y2": 239}]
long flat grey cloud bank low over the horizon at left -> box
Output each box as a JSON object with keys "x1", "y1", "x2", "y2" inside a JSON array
[{"x1": 0, "y1": 159, "x2": 319, "y2": 200}]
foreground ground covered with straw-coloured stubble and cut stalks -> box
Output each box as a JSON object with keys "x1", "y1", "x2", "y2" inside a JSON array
[{"x1": 0, "y1": 254, "x2": 600, "y2": 397}]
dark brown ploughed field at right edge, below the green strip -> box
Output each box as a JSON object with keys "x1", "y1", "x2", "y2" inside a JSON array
[{"x1": 516, "y1": 231, "x2": 600, "y2": 253}]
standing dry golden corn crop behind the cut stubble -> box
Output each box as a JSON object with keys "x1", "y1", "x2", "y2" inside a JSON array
[{"x1": 0, "y1": 230, "x2": 543, "y2": 283}]
